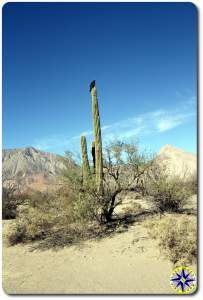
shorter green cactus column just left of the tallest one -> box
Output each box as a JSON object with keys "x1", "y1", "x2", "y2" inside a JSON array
[{"x1": 80, "y1": 135, "x2": 91, "y2": 185}]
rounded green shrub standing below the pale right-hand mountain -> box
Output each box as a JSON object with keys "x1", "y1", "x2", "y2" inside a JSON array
[{"x1": 146, "y1": 166, "x2": 192, "y2": 213}]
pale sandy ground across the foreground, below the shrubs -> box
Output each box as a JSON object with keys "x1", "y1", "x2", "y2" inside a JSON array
[{"x1": 3, "y1": 219, "x2": 179, "y2": 294}]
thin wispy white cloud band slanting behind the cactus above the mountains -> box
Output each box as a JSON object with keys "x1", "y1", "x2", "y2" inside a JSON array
[{"x1": 34, "y1": 96, "x2": 196, "y2": 151}]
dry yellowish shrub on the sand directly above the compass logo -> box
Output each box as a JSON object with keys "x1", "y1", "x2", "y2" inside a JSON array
[{"x1": 147, "y1": 215, "x2": 197, "y2": 265}]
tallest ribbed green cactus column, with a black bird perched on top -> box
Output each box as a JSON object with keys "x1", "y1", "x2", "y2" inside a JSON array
[{"x1": 91, "y1": 86, "x2": 103, "y2": 192}]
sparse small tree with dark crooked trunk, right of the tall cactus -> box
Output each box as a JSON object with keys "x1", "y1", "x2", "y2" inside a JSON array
[{"x1": 102, "y1": 141, "x2": 152, "y2": 222}]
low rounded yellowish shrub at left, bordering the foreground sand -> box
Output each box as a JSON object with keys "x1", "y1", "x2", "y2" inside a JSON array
[{"x1": 8, "y1": 192, "x2": 72, "y2": 245}]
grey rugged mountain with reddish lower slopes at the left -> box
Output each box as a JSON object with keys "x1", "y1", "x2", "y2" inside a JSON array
[{"x1": 2, "y1": 147, "x2": 70, "y2": 190}]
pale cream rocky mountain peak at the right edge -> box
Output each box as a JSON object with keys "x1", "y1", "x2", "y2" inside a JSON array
[{"x1": 157, "y1": 144, "x2": 197, "y2": 178}]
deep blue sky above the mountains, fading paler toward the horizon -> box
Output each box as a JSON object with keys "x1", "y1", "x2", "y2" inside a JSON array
[{"x1": 3, "y1": 2, "x2": 197, "y2": 154}]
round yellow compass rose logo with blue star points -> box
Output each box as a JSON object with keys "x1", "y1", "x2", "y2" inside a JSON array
[{"x1": 170, "y1": 267, "x2": 196, "y2": 294}]
